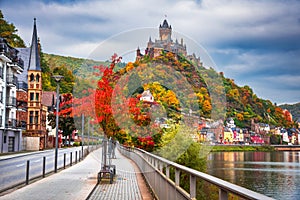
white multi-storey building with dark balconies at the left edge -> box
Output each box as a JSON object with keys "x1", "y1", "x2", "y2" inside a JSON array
[{"x1": 0, "y1": 38, "x2": 24, "y2": 153}]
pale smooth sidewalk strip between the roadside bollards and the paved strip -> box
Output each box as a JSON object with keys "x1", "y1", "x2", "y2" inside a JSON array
[{"x1": 0, "y1": 148, "x2": 101, "y2": 200}]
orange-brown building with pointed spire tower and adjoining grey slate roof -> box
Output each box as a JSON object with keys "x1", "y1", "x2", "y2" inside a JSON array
[{"x1": 18, "y1": 19, "x2": 48, "y2": 150}]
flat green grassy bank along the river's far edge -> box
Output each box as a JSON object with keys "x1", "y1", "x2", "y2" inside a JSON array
[{"x1": 211, "y1": 145, "x2": 276, "y2": 152}]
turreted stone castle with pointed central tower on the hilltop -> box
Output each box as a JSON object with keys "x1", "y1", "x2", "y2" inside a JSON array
[{"x1": 136, "y1": 19, "x2": 202, "y2": 66}]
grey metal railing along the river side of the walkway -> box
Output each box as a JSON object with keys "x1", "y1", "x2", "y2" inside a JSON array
[{"x1": 119, "y1": 146, "x2": 272, "y2": 200}]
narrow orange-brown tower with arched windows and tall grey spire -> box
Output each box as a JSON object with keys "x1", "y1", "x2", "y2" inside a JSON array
[{"x1": 26, "y1": 19, "x2": 46, "y2": 141}]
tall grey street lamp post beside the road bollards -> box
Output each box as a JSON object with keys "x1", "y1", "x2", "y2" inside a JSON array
[{"x1": 52, "y1": 75, "x2": 64, "y2": 173}]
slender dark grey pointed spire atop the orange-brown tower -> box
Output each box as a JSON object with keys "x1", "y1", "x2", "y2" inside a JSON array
[{"x1": 28, "y1": 18, "x2": 42, "y2": 71}]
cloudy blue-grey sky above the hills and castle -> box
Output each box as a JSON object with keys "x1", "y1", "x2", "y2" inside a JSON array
[{"x1": 0, "y1": 0, "x2": 300, "y2": 104}]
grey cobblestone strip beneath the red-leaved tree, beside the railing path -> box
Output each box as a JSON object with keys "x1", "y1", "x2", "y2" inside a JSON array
[{"x1": 88, "y1": 151, "x2": 142, "y2": 200}]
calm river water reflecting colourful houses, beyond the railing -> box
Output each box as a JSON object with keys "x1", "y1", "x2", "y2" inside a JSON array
[{"x1": 207, "y1": 151, "x2": 300, "y2": 200}]
